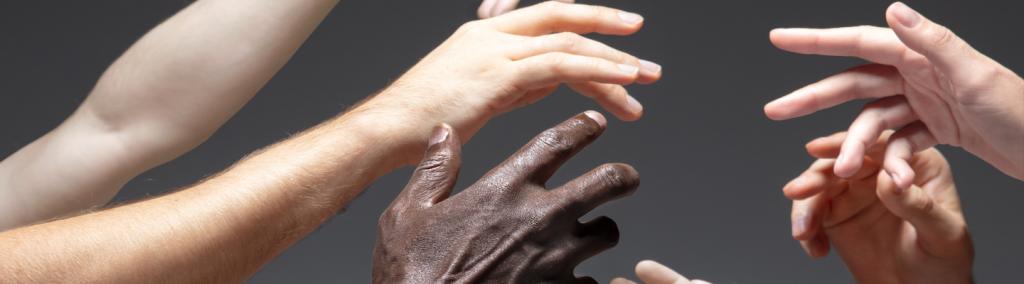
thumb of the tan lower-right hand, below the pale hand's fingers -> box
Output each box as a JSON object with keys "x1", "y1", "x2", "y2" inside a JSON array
[{"x1": 877, "y1": 172, "x2": 967, "y2": 253}]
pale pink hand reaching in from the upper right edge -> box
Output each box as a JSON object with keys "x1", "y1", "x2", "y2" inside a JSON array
[{"x1": 765, "y1": 3, "x2": 1024, "y2": 189}]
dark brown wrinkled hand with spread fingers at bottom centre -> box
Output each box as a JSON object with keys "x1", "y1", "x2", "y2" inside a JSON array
[{"x1": 374, "y1": 112, "x2": 640, "y2": 283}]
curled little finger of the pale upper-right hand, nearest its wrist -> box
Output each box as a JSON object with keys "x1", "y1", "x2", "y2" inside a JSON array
[{"x1": 884, "y1": 122, "x2": 938, "y2": 190}]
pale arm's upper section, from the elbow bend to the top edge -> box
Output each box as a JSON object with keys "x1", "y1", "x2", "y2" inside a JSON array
[{"x1": 84, "y1": 0, "x2": 338, "y2": 167}]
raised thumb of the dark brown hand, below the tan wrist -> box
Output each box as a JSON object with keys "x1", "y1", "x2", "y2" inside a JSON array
[{"x1": 401, "y1": 124, "x2": 462, "y2": 207}]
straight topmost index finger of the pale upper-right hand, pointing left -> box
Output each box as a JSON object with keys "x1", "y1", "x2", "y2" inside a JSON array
[{"x1": 770, "y1": 26, "x2": 920, "y2": 66}]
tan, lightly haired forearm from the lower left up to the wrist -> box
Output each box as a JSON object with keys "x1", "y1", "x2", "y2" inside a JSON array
[{"x1": 0, "y1": 105, "x2": 419, "y2": 282}]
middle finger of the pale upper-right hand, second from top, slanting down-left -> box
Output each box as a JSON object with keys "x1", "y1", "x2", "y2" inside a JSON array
[{"x1": 764, "y1": 65, "x2": 903, "y2": 120}]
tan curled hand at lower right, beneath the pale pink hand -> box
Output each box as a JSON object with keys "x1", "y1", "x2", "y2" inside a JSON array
[{"x1": 783, "y1": 133, "x2": 974, "y2": 283}]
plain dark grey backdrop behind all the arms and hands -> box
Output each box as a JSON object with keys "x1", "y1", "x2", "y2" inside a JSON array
[{"x1": 0, "y1": 0, "x2": 1024, "y2": 283}]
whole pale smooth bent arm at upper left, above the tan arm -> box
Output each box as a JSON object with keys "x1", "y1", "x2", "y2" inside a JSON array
[{"x1": 0, "y1": 0, "x2": 338, "y2": 231}]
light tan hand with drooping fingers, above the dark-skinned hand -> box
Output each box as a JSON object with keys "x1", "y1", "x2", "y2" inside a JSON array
[{"x1": 365, "y1": 2, "x2": 662, "y2": 164}]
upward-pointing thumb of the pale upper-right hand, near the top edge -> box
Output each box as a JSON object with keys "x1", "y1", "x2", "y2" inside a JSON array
[{"x1": 886, "y1": 2, "x2": 984, "y2": 76}]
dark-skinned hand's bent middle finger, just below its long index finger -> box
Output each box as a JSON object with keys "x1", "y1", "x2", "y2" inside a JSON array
[{"x1": 552, "y1": 160, "x2": 640, "y2": 218}]
